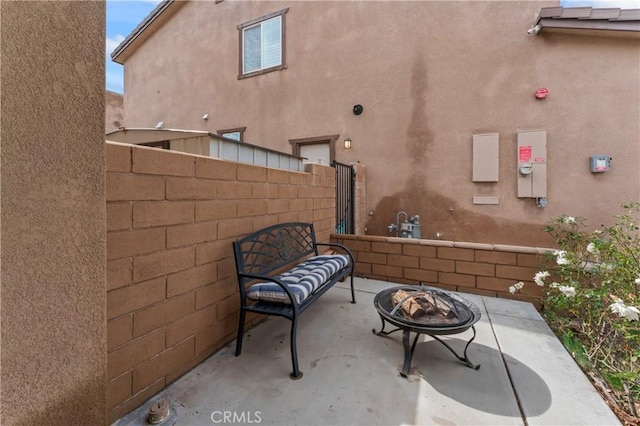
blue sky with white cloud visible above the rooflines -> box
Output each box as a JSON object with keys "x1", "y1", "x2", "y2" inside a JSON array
[{"x1": 106, "y1": 0, "x2": 640, "y2": 93}]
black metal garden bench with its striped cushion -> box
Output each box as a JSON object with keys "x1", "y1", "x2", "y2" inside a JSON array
[{"x1": 233, "y1": 222, "x2": 356, "y2": 379}]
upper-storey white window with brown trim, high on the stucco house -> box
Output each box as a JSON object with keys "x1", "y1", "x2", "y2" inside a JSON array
[{"x1": 238, "y1": 9, "x2": 288, "y2": 78}]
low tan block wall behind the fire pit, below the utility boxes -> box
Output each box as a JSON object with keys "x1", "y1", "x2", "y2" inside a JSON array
[{"x1": 333, "y1": 235, "x2": 553, "y2": 307}]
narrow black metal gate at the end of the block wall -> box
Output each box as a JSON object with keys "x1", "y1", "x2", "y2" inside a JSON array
[{"x1": 331, "y1": 161, "x2": 356, "y2": 234}]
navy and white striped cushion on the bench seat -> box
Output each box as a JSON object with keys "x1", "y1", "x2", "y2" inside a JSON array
[{"x1": 247, "y1": 254, "x2": 349, "y2": 304}]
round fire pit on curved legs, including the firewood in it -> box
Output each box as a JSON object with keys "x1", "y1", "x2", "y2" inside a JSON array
[{"x1": 371, "y1": 285, "x2": 482, "y2": 377}]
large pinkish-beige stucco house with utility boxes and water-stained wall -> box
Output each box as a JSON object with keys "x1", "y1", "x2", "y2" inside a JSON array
[{"x1": 112, "y1": 0, "x2": 640, "y2": 246}]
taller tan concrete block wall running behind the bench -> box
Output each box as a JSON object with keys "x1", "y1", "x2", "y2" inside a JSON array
[{"x1": 106, "y1": 143, "x2": 335, "y2": 422}]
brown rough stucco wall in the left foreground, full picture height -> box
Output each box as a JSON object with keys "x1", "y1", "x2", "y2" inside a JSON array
[{"x1": 0, "y1": 1, "x2": 106, "y2": 425}]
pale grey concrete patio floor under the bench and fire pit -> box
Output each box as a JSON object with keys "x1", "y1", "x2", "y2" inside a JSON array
[{"x1": 114, "y1": 278, "x2": 620, "y2": 426}]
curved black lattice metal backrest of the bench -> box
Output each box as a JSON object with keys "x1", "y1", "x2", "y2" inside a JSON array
[{"x1": 233, "y1": 222, "x2": 318, "y2": 275}]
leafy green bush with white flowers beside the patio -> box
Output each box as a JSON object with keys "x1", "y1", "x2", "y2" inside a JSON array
[{"x1": 510, "y1": 202, "x2": 640, "y2": 424}]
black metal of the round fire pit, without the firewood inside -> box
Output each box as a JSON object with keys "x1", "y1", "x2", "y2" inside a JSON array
[{"x1": 371, "y1": 285, "x2": 481, "y2": 377}]
